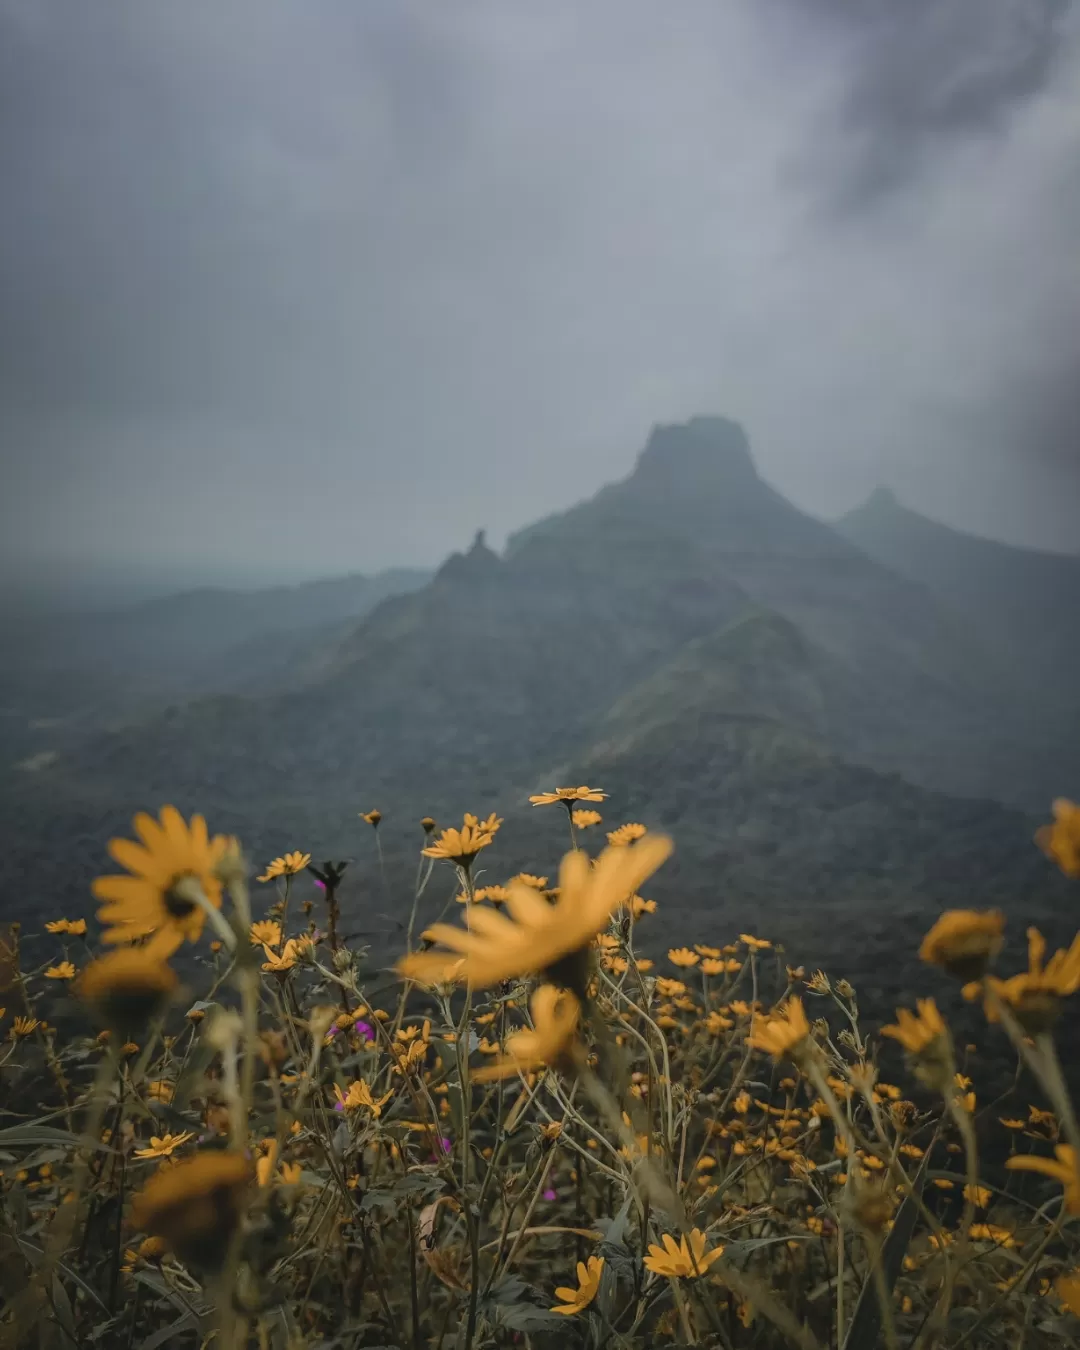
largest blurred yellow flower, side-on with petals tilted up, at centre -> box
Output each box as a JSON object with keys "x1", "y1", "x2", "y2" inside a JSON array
[{"x1": 397, "y1": 836, "x2": 671, "y2": 994}]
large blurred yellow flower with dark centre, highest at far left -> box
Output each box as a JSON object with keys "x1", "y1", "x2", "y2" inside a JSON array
[{"x1": 92, "y1": 806, "x2": 230, "y2": 956}]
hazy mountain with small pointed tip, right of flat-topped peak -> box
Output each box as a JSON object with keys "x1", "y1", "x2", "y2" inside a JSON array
[{"x1": 836, "y1": 487, "x2": 1080, "y2": 723}]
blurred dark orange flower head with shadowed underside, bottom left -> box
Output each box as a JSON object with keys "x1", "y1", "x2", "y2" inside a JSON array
[{"x1": 131, "y1": 1149, "x2": 252, "y2": 1270}]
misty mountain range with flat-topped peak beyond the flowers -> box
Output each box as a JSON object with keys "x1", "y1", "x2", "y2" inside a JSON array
[{"x1": 4, "y1": 417, "x2": 1076, "y2": 1015}]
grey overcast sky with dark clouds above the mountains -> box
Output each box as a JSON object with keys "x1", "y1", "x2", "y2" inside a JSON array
[{"x1": 0, "y1": 0, "x2": 1080, "y2": 599}]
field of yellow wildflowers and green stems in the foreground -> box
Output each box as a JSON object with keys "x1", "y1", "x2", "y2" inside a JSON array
[{"x1": 0, "y1": 787, "x2": 1080, "y2": 1350}]
